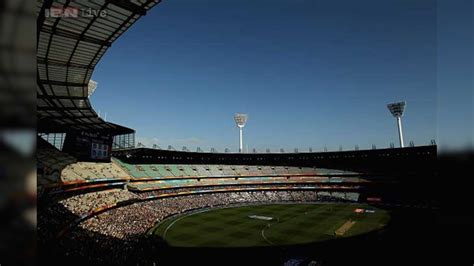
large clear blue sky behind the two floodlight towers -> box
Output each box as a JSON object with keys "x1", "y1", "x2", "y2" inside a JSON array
[{"x1": 91, "y1": 0, "x2": 438, "y2": 151}]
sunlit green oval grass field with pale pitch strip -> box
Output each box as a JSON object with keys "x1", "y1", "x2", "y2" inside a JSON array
[{"x1": 150, "y1": 203, "x2": 390, "y2": 247}]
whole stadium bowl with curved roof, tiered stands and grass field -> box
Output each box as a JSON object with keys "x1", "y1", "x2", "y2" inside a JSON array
[{"x1": 36, "y1": 0, "x2": 436, "y2": 265}]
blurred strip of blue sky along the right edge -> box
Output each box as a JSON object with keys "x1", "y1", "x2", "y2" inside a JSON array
[{"x1": 437, "y1": 0, "x2": 474, "y2": 151}]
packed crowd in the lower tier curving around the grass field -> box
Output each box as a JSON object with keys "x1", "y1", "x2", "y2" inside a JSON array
[{"x1": 38, "y1": 186, "x2": 356, "y2": 264}]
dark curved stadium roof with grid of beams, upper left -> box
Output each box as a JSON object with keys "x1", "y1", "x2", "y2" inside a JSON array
[{"x1": 37, "y1": 0, "x2": 161, "y2": 135}]
